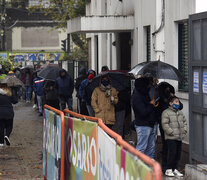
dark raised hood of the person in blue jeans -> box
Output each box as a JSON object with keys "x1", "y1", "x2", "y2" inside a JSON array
[{"x1": 135, "y1": 77, "x2": 150, "y2": 94}]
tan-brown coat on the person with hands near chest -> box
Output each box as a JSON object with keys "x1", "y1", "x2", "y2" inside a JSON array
[{"x1": 91, "y1": 87, "x2": 118, "y2": 125}]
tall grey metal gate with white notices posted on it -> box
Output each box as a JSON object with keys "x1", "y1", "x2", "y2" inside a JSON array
[{"x1": 189, "y1": 12, "x2": 207, "y2": 164}]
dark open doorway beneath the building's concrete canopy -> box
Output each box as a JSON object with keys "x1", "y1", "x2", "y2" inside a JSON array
[{"x1": 119, "y1": 32, "x2": 131, "y2": 70}]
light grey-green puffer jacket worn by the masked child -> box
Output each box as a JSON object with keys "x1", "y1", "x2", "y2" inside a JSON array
[{"x1": 162, "y1": 107, "x2": 187, "y2": 141}]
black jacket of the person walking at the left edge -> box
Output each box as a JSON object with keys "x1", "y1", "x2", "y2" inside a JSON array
[{"x1": 0, "y1": 89, "x2": 18, "y2": 119}]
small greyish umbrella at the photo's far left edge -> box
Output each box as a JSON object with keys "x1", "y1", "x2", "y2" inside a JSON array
[{"x1": 0, "y1": 75, "x2": 24, "y2": 87}]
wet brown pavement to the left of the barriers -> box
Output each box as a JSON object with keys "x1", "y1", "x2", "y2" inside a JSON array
[{"x1": 0, "y1": 102, "x2": 43, "y2": 180}]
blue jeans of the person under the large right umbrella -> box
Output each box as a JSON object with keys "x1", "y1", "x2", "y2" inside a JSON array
[{"x1": 135, "y1": 125, "x2": 155, "y2": 159}]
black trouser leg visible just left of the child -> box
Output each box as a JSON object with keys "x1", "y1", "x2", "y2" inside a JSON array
[{"x1": 159, "y1": 124, "x2": 168, "y2": 172}]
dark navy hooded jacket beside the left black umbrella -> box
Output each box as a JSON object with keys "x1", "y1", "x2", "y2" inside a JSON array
[{"x1": 55, "y1": 69, "x2": 74, "y2": 98}]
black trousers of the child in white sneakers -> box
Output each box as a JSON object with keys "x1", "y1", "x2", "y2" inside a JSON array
[{"x1": 166, "y1": 140, "x2": 182, "y2": 171}]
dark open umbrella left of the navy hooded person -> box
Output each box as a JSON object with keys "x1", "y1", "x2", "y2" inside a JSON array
[{"x1": 38, "y1": 66, "x2": 61, "y2": 81}]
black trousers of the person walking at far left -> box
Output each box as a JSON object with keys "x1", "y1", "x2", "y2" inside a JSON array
[{"x1": 0, "y1": 119, "x2": 13, "y2": 144}]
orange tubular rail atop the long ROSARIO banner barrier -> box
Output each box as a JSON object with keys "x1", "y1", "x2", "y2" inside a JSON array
[{"x1": 64, "y1": 109, "x2": 162, "y2": 180}]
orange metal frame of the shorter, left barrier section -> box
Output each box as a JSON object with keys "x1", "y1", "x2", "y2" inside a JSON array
[{"x1": 44, "y1": 105, "x2": 65, "y2": 180}]
